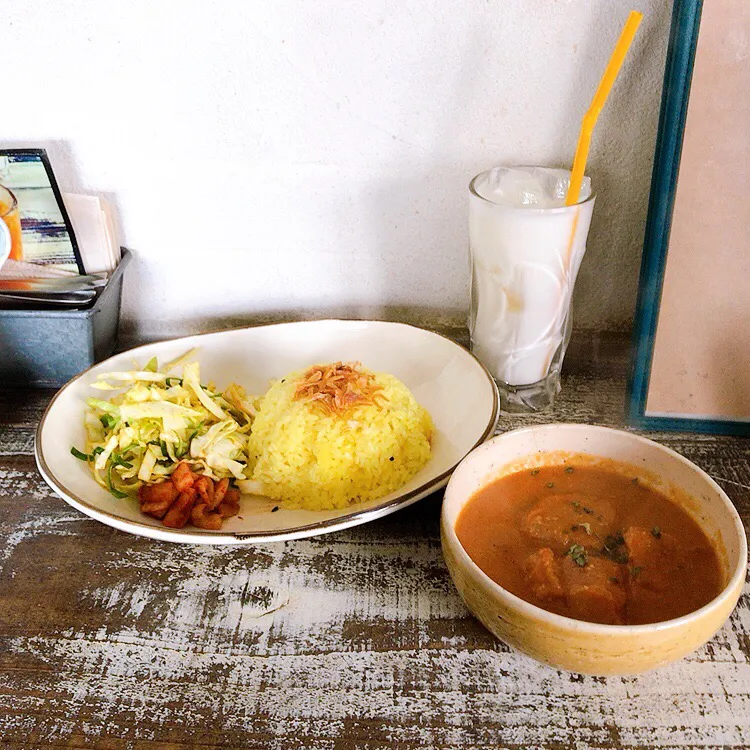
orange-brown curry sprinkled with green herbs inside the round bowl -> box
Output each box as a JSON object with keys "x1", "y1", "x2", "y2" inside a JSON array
[{"x1": 456, "y1": 460, "x2": 723, "y2": 625}]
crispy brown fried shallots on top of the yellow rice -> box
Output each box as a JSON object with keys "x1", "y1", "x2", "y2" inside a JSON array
[{"x1": 294, "y1": 362, "x2": 385, "y2": 416}]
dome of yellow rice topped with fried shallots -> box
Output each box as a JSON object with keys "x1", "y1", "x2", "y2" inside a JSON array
[{"x1": 248, "y1": 362, "x2": 433, "y2": 510}]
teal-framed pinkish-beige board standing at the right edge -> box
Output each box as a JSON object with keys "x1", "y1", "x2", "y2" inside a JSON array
[{"x1": 628, "y1": 0, "x2": 750, "y2": 435}]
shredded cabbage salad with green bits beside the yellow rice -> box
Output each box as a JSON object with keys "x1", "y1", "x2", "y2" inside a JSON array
[{"x1": 71, "y1": 351, "x2": 259, "y2": 497}]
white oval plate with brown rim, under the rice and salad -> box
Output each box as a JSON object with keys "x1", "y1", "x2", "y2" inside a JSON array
[{"x1": 35, "y1": 320, "x2": 498, "y2": 544}]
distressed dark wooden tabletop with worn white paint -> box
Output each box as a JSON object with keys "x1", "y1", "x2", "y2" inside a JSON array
[{"x1": 0, "y1": 339, "x2": 750, "y2": 750}]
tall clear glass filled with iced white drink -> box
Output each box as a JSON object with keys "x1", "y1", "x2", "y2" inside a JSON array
[{"x1": 469, "y1": 167, "x2": 594, "y2": 412}]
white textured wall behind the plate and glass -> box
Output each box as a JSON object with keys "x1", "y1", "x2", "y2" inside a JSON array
[{"x1": 0, "y1": 0, "x2": 671, "y2": 336}]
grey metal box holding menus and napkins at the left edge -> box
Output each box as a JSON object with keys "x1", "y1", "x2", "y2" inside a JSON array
[{"x1": 0, "y1": 250, "x2": 131, "y2": 388}]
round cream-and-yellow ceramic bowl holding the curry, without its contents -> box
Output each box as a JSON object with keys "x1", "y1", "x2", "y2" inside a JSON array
[{"x1": 441, "y1": 424, "x2": 747, "y2": 675}]
